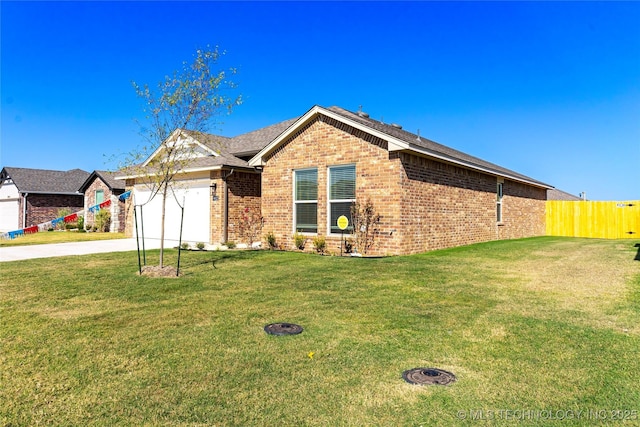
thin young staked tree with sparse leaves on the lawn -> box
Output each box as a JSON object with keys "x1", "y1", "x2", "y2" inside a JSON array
[{"x1": 122, "y1": 46, "x2": 242, "y2": 268}]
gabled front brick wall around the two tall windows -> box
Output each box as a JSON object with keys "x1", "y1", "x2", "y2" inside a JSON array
[{"x1": 262, "y1": 116, "x2": 400, "y2": 254}]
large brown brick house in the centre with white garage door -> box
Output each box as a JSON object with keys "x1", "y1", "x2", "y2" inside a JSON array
[{"x1": 121, "y1": 106, "x2": 552, "y2": 255}]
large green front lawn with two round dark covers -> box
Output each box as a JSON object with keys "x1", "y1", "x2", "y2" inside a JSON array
[{"x1": 0, "y1": 237, "x2": 640, "y2": 426}]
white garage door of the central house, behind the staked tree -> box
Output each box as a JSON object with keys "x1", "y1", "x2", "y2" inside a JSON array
[{"x1": 134, "y1": 180, "x2": 211, "y2": 243}]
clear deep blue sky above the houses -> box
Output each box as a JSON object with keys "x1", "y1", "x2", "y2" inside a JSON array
[{"x1": 0, "y1": 1, "x2": 640, "y2": 200}]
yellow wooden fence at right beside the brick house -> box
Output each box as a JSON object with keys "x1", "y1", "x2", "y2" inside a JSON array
[{"x1": 546, "y1": 200, "x2": 640, "y2": 239}]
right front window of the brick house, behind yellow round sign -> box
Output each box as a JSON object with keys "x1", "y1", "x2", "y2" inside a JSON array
[{"x1": 329, "y1": 165, "x2": 356, "y2": 233}]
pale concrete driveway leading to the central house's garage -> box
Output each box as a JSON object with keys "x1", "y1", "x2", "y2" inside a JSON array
[{"x1": 0, "y1": 239, "x2": 165, "y2": 262}]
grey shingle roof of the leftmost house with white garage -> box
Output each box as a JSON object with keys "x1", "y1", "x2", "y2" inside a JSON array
[{"x1": 2, "y1": 167, "x2": 90, "y2": 194}]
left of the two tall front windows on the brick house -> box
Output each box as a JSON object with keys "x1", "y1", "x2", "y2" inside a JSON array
[{"x1": 293, "y1": 169, "x2": 318, "y2": 233}]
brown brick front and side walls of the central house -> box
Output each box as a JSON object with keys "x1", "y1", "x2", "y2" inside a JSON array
[{"x1": 262, "y1": 116, "x2": 546, "y2": 255}]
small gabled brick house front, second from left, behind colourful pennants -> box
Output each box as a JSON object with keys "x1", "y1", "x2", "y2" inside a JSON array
[{"x1": 80, "y1": 171, "x2": 127, "y2": 232}]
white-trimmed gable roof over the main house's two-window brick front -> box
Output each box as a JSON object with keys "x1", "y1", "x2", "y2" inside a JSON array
[{"x1": 249, "y1": 105, "x2": 552, "y2": 188}]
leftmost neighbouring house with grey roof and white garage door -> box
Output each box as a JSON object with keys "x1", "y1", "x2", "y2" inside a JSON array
[{"x1": 0, "y1": 167, "x2": 89, "y2": 231}]
